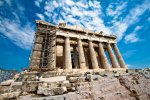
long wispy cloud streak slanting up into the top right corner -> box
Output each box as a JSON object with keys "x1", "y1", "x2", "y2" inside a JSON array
[{"x1": 110, "y1": 0, "x2": 150, "y2": 42}]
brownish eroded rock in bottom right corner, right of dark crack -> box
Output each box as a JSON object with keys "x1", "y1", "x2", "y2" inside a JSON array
[{"x1": 119, "y1": 75, "x2": 150, "y2": 100}]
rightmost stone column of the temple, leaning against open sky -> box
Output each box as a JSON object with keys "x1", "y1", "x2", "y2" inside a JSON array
[{"x1": 113, "y1": 44, "x2": 127, "y2": 68}]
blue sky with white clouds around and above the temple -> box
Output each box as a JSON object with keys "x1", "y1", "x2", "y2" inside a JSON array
[{"x1": 0, "y1": 0, "x2": 150, "y2": 71}]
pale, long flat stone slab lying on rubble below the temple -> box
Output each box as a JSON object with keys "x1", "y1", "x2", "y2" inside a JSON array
[{"x1": 39, "y1": 76, "x2": 66, "y2": 82}]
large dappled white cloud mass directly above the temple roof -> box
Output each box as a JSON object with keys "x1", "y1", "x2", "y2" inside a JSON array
[{"x1": 44, "y1": 0, "x2": 111, "y2": 34}]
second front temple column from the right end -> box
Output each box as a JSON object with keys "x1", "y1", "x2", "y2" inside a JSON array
[{"x1": 107, "y1": 43, "x2": 119, "y2": 68}]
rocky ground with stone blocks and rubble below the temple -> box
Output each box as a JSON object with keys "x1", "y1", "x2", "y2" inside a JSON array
[{"x1": 0, "y1": 68, "x2": 150, "y2": 100}]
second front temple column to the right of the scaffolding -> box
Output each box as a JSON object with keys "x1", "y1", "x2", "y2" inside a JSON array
[{"x1": 78, "y1": 39, "x2": 86, "y2": 69}]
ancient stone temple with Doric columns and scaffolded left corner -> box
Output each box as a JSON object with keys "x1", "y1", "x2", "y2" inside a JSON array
[{"x1": 30, "y1": 20, "x2": 127, "y2": 71}]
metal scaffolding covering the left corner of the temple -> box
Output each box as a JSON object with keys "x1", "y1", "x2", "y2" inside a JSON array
[{"x1": 30, "y1": 24, "x2": 57, "y2": 68}]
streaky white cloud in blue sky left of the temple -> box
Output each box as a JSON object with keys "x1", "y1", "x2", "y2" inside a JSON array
[{"x1": 0, "y1": 19, "x2": 34, "y2": 49}]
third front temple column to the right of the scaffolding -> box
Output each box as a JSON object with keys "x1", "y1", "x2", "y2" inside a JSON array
[{"x1": 89, "y1": 41, "x2": 99, "y2": 69}]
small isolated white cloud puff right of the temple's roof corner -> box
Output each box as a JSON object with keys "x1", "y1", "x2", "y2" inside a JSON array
[{"x1": 125, "y1": 33, "x2": 139, "y2": 43}]
